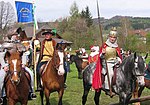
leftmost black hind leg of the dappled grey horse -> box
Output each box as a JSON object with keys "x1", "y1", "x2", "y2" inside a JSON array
[{"x1": 82, "y1": 83, "x2": 91, "y2": 105}]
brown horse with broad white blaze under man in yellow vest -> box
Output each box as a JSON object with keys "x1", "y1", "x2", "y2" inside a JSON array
[{"x1": 40, "y1": 50, "x2": 65, "y2": 105}]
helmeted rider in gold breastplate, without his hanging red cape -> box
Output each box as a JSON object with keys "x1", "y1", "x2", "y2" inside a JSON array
[{"x1": 93, "y1": 27, "x2": 122, "y2": 95}]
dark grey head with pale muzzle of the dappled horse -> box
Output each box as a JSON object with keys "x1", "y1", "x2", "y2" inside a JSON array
[{"x1": 133, "y1": 53, "x2": 148, "y2": 86}]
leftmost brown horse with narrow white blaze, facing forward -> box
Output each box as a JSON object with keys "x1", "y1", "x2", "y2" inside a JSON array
[{"x1": 5, "y1": 52, "x2": 30, "y2": 105}]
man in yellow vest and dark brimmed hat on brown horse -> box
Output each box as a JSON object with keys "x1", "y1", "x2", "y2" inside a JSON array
[{"x1": 36, "y1": 30, "x2": 56, "y2": 91}]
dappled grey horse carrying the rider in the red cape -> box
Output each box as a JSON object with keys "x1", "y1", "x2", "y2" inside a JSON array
[{"x1": 82, "y1": 53, "x2": 147, "y2": 105}]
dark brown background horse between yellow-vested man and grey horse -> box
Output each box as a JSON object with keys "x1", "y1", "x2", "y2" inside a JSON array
[{"x1": 70, "y1": 54, "x2": 88, "y2": 79}]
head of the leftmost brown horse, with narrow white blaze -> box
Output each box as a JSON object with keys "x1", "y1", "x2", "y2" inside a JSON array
[{"x1": 5, "y1": 52, "x2": 22, "y2": 84}]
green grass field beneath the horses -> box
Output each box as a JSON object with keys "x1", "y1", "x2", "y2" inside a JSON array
[{"x1": 25, "y1": 63, "x2": 150, "y2": 105}]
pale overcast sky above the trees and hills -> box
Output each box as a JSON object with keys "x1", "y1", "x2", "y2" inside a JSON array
[{"x1": 0, "y1": 0, "x2": 150, "y2": 22}]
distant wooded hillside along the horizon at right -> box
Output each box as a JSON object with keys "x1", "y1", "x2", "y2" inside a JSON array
[{"x1": 93, "y1": 16, "x2": 150, "y2": 30}]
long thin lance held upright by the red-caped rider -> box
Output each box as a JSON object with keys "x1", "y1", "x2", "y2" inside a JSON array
[{"x1": 97, "y1": 0, "x2": 112, "y2": 96}]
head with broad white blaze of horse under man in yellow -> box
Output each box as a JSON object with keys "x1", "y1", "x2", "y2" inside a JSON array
[{"x1": 52, "y1": 50, "x2": 65, "y2": 75}]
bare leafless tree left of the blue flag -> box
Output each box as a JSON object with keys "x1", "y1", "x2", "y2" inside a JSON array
[{"x1": 0, "y1": 1, "x2": 15, "y2": 35}]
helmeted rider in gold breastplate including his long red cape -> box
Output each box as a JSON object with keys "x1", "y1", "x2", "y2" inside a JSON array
[{"x1": 92, "y1": 27, "x2": 122, "y2": 92}]
